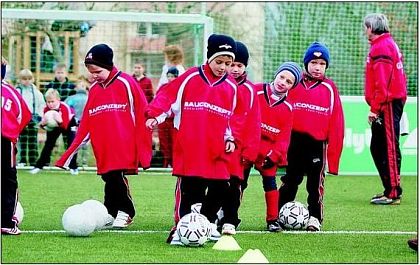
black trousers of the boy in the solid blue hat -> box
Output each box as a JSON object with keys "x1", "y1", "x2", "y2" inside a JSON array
[{"x1": 279, "y1": 131, "x2": 326, "y2": 222}]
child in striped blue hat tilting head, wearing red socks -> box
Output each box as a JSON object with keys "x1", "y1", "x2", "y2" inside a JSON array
[{"x1": 242, "y1": 62, "x2": 302, "y2": 232}]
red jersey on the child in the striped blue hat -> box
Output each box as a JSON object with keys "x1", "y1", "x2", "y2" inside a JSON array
[{"x1": 255, "y1": 83, "x2": 293, "y2": 176}]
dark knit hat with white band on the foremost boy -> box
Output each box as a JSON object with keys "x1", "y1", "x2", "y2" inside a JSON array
[{"x1": 207, "y1": 34, "x2": 236, "y2": 63}]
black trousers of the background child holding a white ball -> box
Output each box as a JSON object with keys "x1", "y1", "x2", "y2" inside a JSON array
[{"x1": 35, "y1": 124, "x2": 77, "y2": 169}]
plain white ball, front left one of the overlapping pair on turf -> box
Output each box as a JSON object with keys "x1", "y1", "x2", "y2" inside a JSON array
[{"x1": 62, "y1": 204, "x2": 96, "y2": 236}]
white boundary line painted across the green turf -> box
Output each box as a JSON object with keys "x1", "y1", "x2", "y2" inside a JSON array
[{"x1": 22, "y1": 230, "x2": 417, "y2": 235}]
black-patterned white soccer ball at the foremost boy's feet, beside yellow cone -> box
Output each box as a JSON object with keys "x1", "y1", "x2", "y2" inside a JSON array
[{"x1": 176, "y1": 213, "x2": 210, "y2": 247}]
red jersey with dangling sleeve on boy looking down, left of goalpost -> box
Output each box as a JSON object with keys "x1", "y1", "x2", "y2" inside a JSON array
[{"x1": 56, "y1": 67, "x2": 152, "y2": 174}]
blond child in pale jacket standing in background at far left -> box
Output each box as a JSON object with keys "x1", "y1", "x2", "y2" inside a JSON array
[{"x1": 16, "y1": 69, "x2": 45, "y2": 166}]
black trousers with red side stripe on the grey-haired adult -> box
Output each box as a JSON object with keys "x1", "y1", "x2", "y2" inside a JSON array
[{"x1": 370, "y1": 100, "x2": 404, "y2": 199}]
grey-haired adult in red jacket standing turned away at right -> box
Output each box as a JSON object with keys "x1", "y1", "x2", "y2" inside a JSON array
[{"x1": 364, "y1": 14, "x2": 407, "y2": 204}]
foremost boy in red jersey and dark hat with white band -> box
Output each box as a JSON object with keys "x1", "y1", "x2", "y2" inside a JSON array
[{"x1": 146, "y1": 34, "x2": 237, "y2": 242}]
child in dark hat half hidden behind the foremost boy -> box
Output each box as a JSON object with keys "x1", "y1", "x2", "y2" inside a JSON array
[{"x1": 218, "y1": 41, "x2": 261, "y2": 234}]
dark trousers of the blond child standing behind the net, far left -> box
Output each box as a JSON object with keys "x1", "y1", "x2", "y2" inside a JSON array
[{"x1": 19, "y1": 121, "x2": 38, "y2": 166}]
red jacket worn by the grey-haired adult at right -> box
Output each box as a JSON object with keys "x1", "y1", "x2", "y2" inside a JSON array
[{"x1": 365, "y1": 33, "x2": 407, "y2": 114}]
